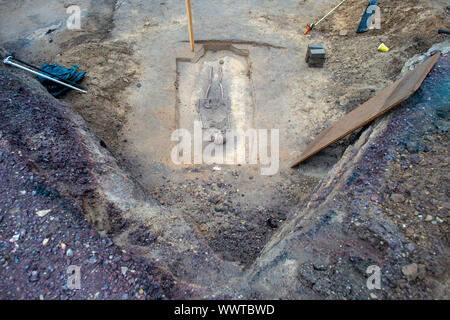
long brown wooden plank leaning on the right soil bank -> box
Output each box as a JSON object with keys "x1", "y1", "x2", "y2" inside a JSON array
[{"x1": 291, "y1": 53, "x2": 440, "y2": 168}]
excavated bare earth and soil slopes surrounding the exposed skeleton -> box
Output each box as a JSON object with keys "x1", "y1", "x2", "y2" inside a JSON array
[{"x1": 0, "y1": 0, "x2": 450, "y2": 299}]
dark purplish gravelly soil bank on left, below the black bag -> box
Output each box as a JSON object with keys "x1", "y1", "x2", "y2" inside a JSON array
[{"x1": 0, "y1": 70, "x2": 190, "y2": 299}]
